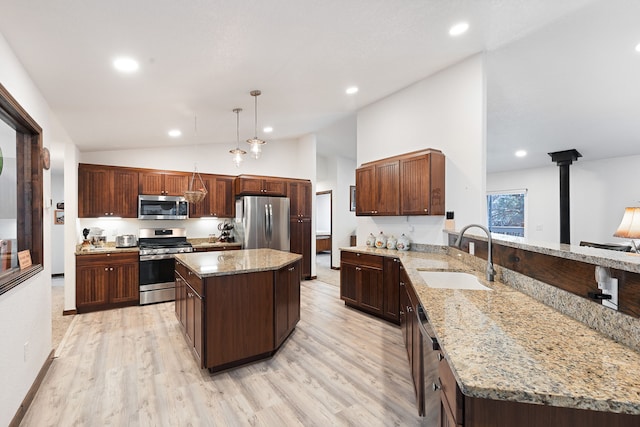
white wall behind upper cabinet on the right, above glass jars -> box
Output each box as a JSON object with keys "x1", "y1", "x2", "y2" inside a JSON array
[{"x1": 357, "y1": 55, "x2": 486, "y2": 244}]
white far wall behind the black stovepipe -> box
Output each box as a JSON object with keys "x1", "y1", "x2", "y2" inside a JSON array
[{"x1": 487, "y1": 156, "x2": 640, "y2": 244}]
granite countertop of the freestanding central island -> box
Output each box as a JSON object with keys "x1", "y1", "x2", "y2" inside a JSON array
[{"x1": 176, "y1": 249, "x2": 302, "y2": 278}]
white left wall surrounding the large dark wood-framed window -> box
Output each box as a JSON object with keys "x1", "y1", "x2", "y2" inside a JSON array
[{"x1": 0, "y1": 34, "x2": 53, "y2": 425}]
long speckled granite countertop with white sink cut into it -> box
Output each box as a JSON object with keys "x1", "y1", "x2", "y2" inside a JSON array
[{"x1": 341, "y1": 247, "x2": 640, "y2": 414}]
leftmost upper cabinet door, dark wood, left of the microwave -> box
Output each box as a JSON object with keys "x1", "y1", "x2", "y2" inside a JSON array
[{"x1": 78, "y1": 165, "x2": 111, "y2": 218}]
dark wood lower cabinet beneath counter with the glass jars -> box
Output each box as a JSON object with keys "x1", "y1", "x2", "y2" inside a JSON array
[{"x1": 340, "y1": 251, "x2": 400, "y2": 324}]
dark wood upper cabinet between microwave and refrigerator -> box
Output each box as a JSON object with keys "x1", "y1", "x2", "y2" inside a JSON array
[{"x1": 189, "y1": 174, "x2": 236, "y2": 218}]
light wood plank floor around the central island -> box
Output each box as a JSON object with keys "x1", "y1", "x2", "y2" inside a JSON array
[{"x1": 21, "y1": 280, "x2": 421, "y2": 427}]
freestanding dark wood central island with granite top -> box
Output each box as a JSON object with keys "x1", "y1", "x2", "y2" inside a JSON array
[{"x1": 175, "y1": 249, "x2": 302, "y2": 372}]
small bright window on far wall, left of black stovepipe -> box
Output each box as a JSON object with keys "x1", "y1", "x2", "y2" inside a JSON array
[{"x1": 487, "y1": 190, "x2": 527, "y2": 237}]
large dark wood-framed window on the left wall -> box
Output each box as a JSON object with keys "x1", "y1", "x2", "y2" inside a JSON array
[{"x1": 0, "y1": 84, "x2": 42, "y2": 295}]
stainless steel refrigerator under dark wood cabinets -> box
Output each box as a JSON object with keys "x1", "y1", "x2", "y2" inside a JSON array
[{"x1": 235, "y1": 196, "x2": 290, "y2": 251}]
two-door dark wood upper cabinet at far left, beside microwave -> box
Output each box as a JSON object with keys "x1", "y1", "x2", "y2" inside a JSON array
[{"x1": 78, "y1": 164, "x2": 138, "y2": 218}]
